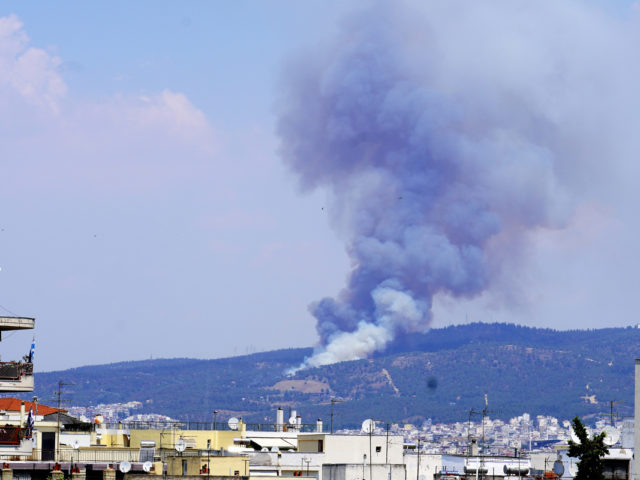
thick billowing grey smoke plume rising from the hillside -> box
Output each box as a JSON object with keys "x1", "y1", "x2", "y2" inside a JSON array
[{"x1": 279, "y1": 2, "x2": 640, "y2": 374}]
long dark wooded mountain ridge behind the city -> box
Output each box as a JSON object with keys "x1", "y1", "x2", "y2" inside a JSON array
[{"x1": 28, "y1": 323, "x2": 640, "y2": 426}]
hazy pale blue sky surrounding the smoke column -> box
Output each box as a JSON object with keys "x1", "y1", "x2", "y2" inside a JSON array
[{"x1": 0, "y1": 0, "x2": 640, "y2": 370}]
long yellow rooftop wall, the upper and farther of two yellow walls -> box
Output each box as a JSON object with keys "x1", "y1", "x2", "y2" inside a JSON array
[{"x1": 129, "y1": 430, "x2": 240, "y2": 450}]
